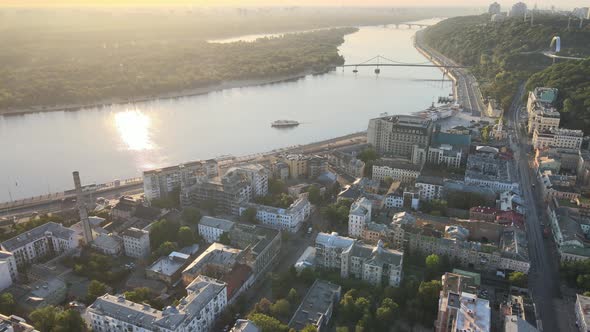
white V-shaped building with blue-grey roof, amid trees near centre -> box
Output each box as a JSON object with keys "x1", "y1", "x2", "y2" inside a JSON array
[{"x1": 239, "y1": 195, "x2": 311, "y2": 233}]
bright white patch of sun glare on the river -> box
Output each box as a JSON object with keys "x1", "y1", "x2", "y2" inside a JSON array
[{"x1": 115, "y1": 110, "x2": 154, "y2": 151}]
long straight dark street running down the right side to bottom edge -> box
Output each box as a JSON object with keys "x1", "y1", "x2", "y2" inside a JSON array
[{"x1": 506, "y1": 86, "x2": 559, "y2": 331}]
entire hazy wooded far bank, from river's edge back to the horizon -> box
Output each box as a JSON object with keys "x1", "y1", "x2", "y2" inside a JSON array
[{"x1": 0, "y1": 8, "x2": 470, "y2": 114}]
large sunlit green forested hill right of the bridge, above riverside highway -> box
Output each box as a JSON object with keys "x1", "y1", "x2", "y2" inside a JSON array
[{"x1": 425, "y1": 14, "x2": 590, "y2": 109}]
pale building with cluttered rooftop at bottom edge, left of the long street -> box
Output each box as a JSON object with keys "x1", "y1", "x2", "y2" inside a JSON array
[{"x1": 435, "y1": 272, "x2": 492, "y2": 332}]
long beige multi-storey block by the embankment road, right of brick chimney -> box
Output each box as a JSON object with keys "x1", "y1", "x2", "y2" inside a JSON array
[{"x1": 143, "y1": 160, "x2": 219, "y2": 203}]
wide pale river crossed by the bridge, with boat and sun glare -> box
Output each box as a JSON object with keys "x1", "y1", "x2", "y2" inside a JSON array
[{"x1": 0, "y1": 21, "x2": 452, "y2": 202}]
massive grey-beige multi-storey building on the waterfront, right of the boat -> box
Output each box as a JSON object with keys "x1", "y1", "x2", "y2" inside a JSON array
[{"x1": 367, "y1": 115, "x2": 433, "y2": 159}]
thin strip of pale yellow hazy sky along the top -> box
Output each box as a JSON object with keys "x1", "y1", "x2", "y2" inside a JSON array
[{"x1": 0, "y1": 0, "x2": 590, "y2": 8}]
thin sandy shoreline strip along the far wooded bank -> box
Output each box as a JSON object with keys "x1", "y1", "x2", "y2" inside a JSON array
[{"x1": 0, "y1": 69, "x2": 331, "y2": 116}]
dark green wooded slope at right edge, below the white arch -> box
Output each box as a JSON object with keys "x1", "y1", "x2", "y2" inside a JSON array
[{"x1": 527, "y1": 59, "x2": 590, "y2": 134}]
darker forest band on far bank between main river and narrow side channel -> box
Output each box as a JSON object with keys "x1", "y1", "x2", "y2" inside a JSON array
[{"x1": 0, "y1": 28, "x2": 356, "y2": 108}]
